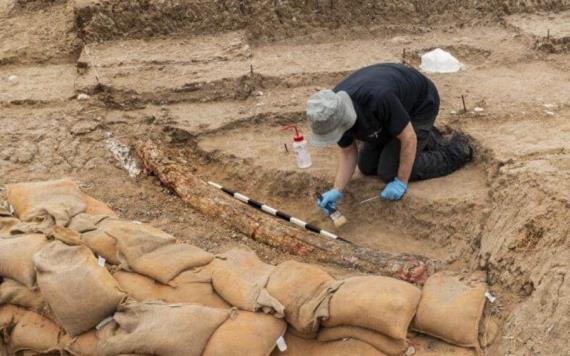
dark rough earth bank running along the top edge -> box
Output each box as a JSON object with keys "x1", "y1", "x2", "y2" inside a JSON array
[{"x1": 74, "y1": 0, "x2": 569, "y2": 41}]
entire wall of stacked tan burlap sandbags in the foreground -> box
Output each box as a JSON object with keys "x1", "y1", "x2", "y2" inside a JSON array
[{"x1": 0, "y1": 180, "x2": 485, "y2": 356}]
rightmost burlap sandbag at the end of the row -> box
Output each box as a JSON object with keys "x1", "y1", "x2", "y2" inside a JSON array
[{"x1": 413, "y1": 272, "x2": 487, "y2": 348}]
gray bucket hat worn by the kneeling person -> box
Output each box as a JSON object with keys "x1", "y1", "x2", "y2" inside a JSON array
[{"x1": 307, "y1": 90, "x2": 356, "y2": 147}]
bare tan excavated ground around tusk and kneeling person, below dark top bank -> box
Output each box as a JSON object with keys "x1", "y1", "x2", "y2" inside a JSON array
[{"x1": 0, "y1": 2, "x2": 570, "y2": 355}]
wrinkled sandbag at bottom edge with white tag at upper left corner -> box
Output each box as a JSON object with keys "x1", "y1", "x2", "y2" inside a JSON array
[{"x1": 97, "y1": 303, "x2": 230, "y2": 356}]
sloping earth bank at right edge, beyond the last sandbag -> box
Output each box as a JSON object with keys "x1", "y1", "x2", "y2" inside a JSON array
[{"x1": 474, "y1": 153, "x2": 570, "y2": 355}]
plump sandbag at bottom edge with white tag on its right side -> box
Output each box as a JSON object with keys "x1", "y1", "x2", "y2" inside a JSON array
[{"x1": 203, "y1": 311, "x2": 287, "y2": 356}]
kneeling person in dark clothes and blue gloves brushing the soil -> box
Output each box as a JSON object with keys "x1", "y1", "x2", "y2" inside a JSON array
[{"x1": 307, "y1": 64, "x2": 472, "y2": 213}]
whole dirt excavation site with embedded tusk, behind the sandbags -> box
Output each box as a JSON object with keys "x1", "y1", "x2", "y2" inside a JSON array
[{"x1": 0, "y1": 0, "x2": 570, "y2": 356}]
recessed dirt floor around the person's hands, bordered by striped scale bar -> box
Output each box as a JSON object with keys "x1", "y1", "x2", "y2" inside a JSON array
[{"x1": 198, "y1": 119, "x2": 487, "y2": 261}]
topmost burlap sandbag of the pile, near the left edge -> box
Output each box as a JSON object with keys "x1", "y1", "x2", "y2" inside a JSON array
[{"x1": 6, "y1": 179, "x2": 87, "y2": 226}]
